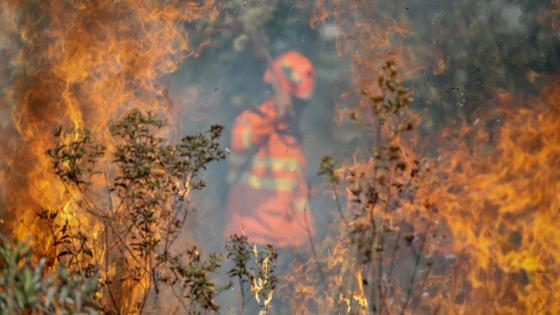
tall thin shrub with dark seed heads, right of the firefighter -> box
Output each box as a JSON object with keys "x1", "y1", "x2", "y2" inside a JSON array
[{"x1": 278, "y1": 62, "x2": 434, "y2": 314}]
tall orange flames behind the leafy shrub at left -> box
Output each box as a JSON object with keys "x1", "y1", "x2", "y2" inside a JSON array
[{"x1": 0, "y1": 0, "x2": 217, "y2": 309}]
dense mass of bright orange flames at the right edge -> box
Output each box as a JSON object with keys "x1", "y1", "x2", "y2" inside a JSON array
[{"x1": 424, "y1": 78, "x2": 560, "y2": 314}]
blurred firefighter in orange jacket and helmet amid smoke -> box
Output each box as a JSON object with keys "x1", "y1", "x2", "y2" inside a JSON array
[{"x1": 225, "y1": 51, "x2": 315, "y2": 250}]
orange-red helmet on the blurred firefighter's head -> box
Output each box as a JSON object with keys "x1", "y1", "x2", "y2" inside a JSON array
[{"x1": 263, "y1": 50, "x2": 315, "y2": 99}]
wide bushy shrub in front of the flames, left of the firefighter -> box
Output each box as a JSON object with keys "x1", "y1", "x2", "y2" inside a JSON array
[{"x1": 38, "y1": 110, "x2": 225, "y2": 313}]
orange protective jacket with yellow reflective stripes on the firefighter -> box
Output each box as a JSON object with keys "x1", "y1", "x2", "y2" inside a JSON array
[{"x1": 225, "y1": 100, "x2": 313, "y2": 248}]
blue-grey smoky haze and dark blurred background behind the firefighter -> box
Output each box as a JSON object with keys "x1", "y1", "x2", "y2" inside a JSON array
[{"x1": 161, "y1": 0, "x2": 560, "y2": 254}]
